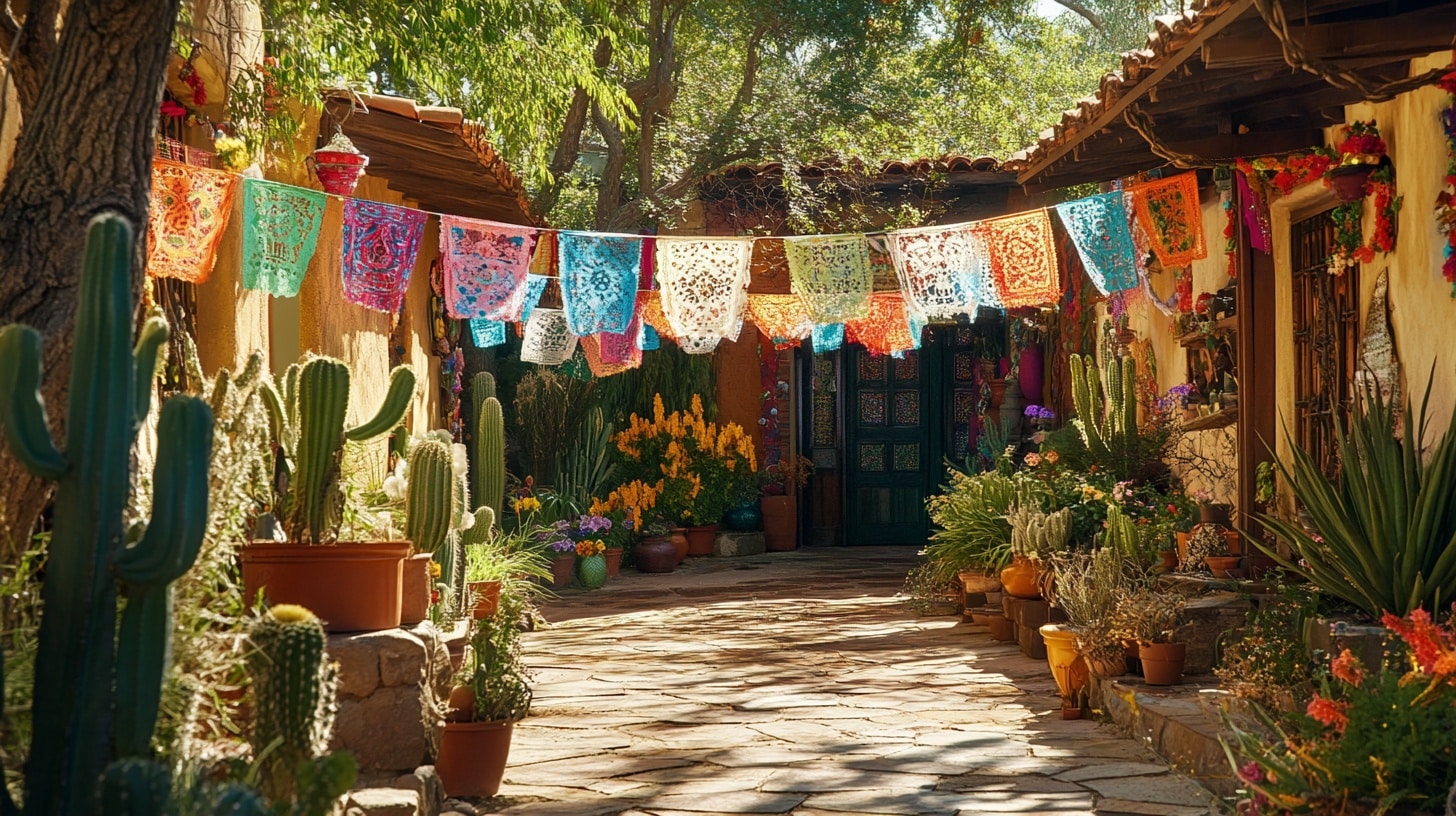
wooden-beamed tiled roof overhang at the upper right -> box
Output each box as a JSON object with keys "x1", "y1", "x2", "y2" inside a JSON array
[{"x1": 1013, "y1": 0, "x2": 1456, "y2": 189}]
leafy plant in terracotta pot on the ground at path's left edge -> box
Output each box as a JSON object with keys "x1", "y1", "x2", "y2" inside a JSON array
[{"x1": 435, "y1": 593, "x2": 531, "y2": 797}]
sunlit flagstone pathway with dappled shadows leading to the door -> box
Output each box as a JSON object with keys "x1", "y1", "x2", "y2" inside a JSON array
[{"x1": 478, "y1": 548, "x2": 1217, "y2": 816}]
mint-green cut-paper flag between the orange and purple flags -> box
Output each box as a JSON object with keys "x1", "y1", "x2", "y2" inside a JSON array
[{"x1": 242, "y1": 178, "x2": 328, "y2": 297}]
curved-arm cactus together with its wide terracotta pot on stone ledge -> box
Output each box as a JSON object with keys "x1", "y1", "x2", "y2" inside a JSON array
[{"x1": 242, "y1": 357, "x2": 415, "y2": 632}]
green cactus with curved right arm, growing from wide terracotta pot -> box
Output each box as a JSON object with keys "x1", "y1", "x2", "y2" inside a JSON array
[{"x1": 261, "y1": 357, "x2": 415, "y2": 544}]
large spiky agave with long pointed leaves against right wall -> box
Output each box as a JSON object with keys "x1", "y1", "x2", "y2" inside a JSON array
[{"x1": 1251, "y1": 370, "x2": 1456, "y2": 618}]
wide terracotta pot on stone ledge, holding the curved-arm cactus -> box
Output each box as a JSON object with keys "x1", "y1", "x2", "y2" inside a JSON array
[{"x1": 242, "y1": 541, "x2": 411, "y2": 632}]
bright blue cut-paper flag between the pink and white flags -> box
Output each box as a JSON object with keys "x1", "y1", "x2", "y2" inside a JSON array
[{"x1": 556, "y1": 232, "x2": 642, "y2": 335}]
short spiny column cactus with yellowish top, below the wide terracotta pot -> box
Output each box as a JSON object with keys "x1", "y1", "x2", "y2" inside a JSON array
[{"x1": 246, "y1": 603, "x2": 335, "y2": 803}]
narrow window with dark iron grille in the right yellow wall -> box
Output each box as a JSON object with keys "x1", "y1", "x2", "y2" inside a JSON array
[{"x1": 1290, "y1": 211, "x2": 1360, "y2": 476}]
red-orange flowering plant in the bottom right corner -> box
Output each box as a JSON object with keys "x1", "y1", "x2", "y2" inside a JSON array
[{"x1": 1226, "y1": 609, "x2": 1456, "y2": 815}]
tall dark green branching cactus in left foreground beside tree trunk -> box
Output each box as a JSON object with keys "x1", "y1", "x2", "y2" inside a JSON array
[{"x1": 0, "y1": 213, "x2": 213, "y2": 815}]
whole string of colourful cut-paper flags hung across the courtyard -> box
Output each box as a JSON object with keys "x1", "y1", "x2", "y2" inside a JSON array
[{"x1": 147, "y1": 159, "x2": 1207, "y2": 374}]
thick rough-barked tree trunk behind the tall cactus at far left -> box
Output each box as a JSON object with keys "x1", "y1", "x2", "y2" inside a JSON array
[{"x1": 0, "y1": 0, "x2": 179, "y2": 560}]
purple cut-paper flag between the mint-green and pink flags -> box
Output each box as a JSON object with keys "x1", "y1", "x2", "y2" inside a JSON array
[{"x1": 339, "y1": 198, "x2": 427, "y2": 313}]
